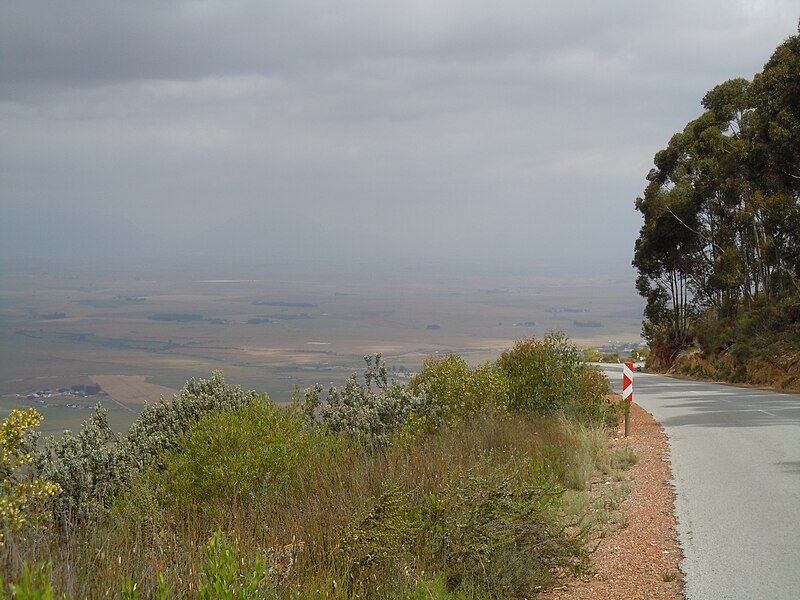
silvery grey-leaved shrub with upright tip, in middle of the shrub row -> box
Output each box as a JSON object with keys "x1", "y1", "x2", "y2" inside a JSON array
[{"x1": 303, "y1": 354, "x2": 428, "y2": 446}]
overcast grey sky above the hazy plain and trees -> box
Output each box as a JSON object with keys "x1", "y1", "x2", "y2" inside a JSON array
[{"x1": 0, "y1": 0, "x2": 800, "y2": 260}]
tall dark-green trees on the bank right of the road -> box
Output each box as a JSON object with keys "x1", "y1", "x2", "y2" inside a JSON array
[{"x1": 634, "y1": 28, "x2": 800, "y2": 389}]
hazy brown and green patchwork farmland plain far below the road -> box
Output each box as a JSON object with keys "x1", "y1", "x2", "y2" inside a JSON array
[{"x1": 0, "y1": 260, "x2": 642, "y2": 430}]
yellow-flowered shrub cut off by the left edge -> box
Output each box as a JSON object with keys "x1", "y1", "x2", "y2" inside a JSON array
[{"x1": 0, "y1": 408, "x2": 61, "y2": 548}]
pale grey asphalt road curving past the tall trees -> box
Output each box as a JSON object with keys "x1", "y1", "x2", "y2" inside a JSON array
[{"x1": 603, "y1": 365, "x2": 800, "y2": 600}]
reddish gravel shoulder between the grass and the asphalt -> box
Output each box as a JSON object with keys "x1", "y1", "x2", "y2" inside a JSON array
[{"x1": 544, "y1": 404, "x2": 683, "y2": 600}]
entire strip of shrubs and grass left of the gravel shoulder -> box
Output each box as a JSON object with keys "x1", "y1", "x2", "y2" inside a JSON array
[{"x1": 0, "y1": 335, "x2": 634, "y2": 598}]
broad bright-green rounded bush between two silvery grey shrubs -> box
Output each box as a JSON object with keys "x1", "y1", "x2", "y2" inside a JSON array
[{"x1": 162, "y1": 396, "x2": 342, "y2": 513}]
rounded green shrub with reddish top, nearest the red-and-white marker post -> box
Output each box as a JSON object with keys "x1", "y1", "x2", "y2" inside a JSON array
[{"x1": 497, "y1": 332, "x2": 582, "y2": 414}]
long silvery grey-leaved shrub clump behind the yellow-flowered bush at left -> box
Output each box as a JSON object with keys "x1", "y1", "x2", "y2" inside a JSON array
[{"x1": 34, "y1": 372, "x2": 257, "y2": 527}]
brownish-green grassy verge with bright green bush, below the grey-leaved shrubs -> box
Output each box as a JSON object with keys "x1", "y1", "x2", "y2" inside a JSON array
[{"x1": 3, "y1": 404, "x2": 631, "y2": 598}]
